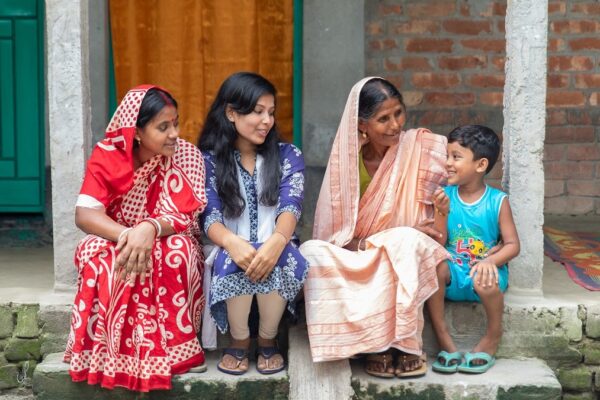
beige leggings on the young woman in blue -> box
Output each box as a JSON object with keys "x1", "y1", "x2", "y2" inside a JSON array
[{"x1": 225, "y1": 290, "x2": 287, "y2": 340}]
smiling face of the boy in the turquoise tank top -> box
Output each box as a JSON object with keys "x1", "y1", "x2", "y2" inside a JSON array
[{"x1": 446, "y1": 142, "x2": 488, "y2": 186}]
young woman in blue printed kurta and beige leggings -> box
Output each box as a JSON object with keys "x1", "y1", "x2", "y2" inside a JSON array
[{"x1": 199, "y1": 73, "x2": 308, "y2": 374}]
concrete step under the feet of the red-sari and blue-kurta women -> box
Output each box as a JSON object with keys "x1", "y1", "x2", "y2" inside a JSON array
[{"x1": 33, "y1": 351, "x2": 289, "y2": 400}]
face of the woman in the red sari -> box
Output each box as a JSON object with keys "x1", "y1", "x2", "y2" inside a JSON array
[{"x1": 136, "y1": 105, "x2": 179, "y2": 162}]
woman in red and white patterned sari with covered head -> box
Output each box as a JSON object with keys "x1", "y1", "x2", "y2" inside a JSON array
[{"x1": 64, "y1": 85, "x2": 206, "y2": 392}]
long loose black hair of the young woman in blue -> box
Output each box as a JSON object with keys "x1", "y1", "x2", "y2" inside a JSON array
[{"x1": 198, "y1": 72, "x2": 281, "y2": 218}]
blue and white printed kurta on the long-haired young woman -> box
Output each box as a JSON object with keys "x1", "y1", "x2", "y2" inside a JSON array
[{"x1": 201, "y1": 143, "x2": 308, "y2": 333}]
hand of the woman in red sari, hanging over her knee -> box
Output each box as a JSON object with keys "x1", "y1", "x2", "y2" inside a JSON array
[{"x1": 116, "y1": 221, "x2": 156, "y2": 285}]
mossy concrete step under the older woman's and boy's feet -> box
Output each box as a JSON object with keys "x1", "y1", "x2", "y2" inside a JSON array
[{"x1": 350, "y1": 358, "x2": 561, "y2": 400}]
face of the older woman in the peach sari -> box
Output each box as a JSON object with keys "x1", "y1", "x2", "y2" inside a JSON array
[{"x1": 358, "y1": 97, "x2": 406, "y2": 147}]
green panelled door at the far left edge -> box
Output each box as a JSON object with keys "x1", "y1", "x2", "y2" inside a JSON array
[{"x1": 0, "y1": 0, "x2": 44, "y2": 212}]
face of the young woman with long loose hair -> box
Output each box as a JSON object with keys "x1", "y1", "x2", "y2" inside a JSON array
[{"x1": 227, "y1": 94, "x2": 275, "y2": 149}]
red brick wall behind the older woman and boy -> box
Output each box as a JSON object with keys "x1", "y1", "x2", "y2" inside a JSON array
[{"x1": 365, "y1": 0, "x2": 600, "y2": 214}]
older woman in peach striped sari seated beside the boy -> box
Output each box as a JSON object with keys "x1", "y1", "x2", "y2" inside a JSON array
[{"x1": 300, "y1": 78, "x2": 447, "y2": 378}]
